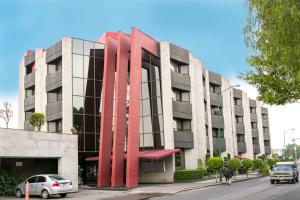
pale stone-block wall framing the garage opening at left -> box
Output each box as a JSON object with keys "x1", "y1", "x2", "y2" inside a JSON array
[{"x1": 0, "y1": 128, "x2": 78, "y2": 189}]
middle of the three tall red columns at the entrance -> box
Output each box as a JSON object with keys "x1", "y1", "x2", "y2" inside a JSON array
[{"x1": 111, "y1": 33, "x2": 130, "y2": 187}]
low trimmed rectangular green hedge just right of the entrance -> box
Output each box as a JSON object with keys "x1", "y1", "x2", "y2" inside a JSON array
[{"x1": 174, "y1": 168, "x2": 206, "y2": 181}]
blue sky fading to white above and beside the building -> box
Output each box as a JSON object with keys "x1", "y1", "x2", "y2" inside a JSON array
[{"x1": 0, "y1": 0, "x2": 300, "y2": 148}]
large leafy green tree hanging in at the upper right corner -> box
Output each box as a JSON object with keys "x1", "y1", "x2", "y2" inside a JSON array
[{"x1": 241, "y1": 0, "x2": 300, "y2": 105}]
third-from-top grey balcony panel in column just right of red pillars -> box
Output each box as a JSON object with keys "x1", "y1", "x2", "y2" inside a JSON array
[{"x1": 173, "y1": 101, "x2": 193, "y2": 119}]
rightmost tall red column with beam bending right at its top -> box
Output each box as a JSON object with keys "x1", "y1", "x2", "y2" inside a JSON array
[{"x1": 126, "y1": 28, "x2": 156, "y2": 187}]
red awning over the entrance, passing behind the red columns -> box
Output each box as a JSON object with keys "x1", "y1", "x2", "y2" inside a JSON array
[{"x1": 85, "y1": 149, "x2": 180, "y2": 161}]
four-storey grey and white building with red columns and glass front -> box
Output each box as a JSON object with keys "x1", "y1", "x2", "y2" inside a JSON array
[{"x1": 19, "y1": 28, "x2": 271, "y2": 187}]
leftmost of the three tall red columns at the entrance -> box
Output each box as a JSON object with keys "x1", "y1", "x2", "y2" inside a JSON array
[{"x1": 97, "y1": 35, "x2": 117, "y2": 187}]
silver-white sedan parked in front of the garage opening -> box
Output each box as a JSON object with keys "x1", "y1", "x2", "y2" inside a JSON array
[{"x1": 15, "y1": 174, "x2": 73, "y2": 199}]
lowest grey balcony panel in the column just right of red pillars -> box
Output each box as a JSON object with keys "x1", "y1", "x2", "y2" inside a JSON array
[{"x1": 174, "y1": 130, "x2": 194, "y2": 149}]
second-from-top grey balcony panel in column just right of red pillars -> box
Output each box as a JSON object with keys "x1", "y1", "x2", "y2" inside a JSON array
[{"x1": 171, "y1": 71, "x2": 191, "y2": 91}]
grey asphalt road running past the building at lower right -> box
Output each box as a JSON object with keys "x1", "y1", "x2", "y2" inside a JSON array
[{"x1": 151, "y1": 177, "x2": 300, "y2": 200}]
